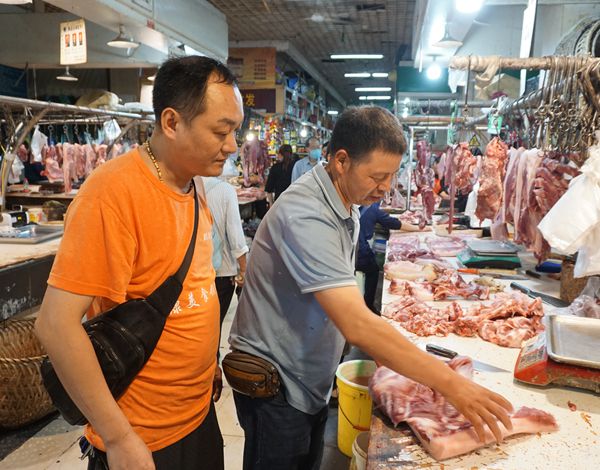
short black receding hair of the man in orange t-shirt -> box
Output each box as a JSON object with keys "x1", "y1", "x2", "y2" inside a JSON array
[{"x1": 152, "y1": 55, "x2": 237, "y2": 124}]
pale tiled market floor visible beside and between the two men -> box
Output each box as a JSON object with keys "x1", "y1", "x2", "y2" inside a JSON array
[{"x1": 0, "y1": 298, "x2": 360, "y2": 470}]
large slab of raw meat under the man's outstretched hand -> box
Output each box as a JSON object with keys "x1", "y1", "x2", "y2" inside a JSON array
[{"x1": 369, "y1": 356, "x2": 558, "y2": 460}]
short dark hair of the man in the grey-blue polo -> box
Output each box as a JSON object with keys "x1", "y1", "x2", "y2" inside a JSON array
[{"x1": 329, "y1": 106, "x2": 406, "y2": 161}]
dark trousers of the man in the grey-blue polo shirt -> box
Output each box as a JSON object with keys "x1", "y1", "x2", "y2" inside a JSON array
[{"x1": 233, "y1": 390, "x2": 327, "y2": 470}]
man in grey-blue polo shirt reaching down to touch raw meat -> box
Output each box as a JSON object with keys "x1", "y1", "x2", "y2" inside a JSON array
[{"x1": 229, "y1": 106, "x2": 512, "y2": 470}]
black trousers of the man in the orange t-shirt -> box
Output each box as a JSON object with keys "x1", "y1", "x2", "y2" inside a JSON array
[{"x1": 88, "y1": 403, "x2": 225, "y2": 470}]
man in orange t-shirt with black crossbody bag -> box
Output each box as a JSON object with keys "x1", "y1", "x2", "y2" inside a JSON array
[{"x1": 36, "y1": 56, "x2": 243, "y2": 470}]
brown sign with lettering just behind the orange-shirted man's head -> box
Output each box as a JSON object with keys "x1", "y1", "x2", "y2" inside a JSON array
[{"x1": 227, "y1": 47, "x2": 276, "y2": 88}]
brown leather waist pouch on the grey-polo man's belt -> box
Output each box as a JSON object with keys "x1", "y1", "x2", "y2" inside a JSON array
[{"x1": 221, "y1": 351, "x2": 281, "y2": 398}]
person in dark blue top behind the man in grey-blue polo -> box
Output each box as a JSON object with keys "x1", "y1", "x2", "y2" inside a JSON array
[{"x1": 356, "y1": 202, "x2": 419, "y2": 315}]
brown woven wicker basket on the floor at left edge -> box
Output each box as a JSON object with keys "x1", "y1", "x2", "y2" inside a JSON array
[{"x1": 0, "y1": 320, "x2": 54, "y2": 429}]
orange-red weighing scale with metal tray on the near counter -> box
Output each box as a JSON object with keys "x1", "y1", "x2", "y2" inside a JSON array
[{"x1": 514, "y1": 315, "x2": 600, "y2": 393}]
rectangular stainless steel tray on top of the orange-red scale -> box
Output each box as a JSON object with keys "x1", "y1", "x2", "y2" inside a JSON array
[{"x1": 546, "y1": 315, "x2": 600, "y2": 369}]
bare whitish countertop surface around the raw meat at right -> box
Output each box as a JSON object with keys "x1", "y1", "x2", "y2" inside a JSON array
[{"x1": 367, "y1": 232, "x2": 600, "y2": 470}]
